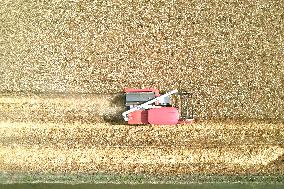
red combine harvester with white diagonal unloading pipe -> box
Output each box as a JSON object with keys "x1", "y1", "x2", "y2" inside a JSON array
[{"x1": 122, "y1": 88, "x2": 194, "y2": 125}]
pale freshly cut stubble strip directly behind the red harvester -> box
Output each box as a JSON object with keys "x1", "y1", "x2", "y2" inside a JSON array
[{"x1": 0, "y1": 93, "x2": 123, "y2": 123}]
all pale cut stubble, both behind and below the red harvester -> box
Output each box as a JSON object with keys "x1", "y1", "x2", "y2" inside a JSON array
[{"x1": 0, "y1": 93, "x2": 284, "y2": 175}]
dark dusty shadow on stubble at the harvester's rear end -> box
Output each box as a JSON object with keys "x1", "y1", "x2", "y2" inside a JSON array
[{"x1": 103, "y1": 94, "x2": 125, "y2": 125}]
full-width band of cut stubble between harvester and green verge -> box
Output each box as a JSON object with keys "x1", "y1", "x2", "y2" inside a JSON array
[{"x1": 0, "y1": 122, "x2": 284, "y2": 175}]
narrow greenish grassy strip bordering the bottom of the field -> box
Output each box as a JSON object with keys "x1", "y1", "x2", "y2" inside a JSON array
[{"x1": 0, "y1": 172, "x2": 284, "y2": 184}]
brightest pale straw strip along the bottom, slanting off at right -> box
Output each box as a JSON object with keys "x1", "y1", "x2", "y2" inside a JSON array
[{"x1": 0, "y1": 145, "x2": 284, "y2": 174}]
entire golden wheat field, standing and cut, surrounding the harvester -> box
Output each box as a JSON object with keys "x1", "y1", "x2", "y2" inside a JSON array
[{"x1": 0, "y1": 0, "x2": 284, "y2": 180}]
